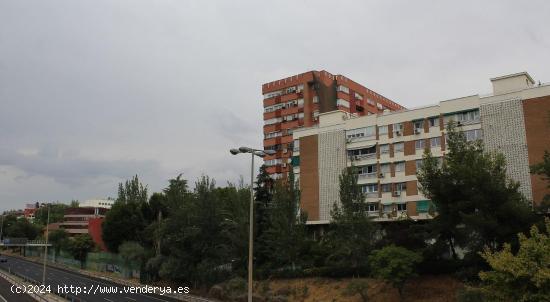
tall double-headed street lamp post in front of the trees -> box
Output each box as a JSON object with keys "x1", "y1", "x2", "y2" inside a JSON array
[{"x1": 229, "y1": 147, "x2": 275, "y2": 302}]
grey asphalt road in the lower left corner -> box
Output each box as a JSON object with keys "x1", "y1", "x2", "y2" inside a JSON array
[{"x1": 0, "y1": 256, "x2": 182, "y2": 302}]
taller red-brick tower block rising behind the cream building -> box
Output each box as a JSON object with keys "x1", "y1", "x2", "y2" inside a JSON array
[{"x1": 262, "y1": 70, "x2": 404, "y2": 178}]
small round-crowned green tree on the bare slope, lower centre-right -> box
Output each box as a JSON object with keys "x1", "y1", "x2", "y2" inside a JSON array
[{"x1": 369, "y1": 245, "x2": 422, "y2": 297}]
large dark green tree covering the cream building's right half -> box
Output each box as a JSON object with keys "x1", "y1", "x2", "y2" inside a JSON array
[{"x1": 418, "y1": 122, "x2": 534, "y2": 259}]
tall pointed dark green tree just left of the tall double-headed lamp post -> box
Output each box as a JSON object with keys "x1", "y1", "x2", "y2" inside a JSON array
[{"x1": 159, "y1": 176, "x2": 230, "y2": 284}]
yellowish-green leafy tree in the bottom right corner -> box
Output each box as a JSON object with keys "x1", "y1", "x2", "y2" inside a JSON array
[{"x1": 479, "y1": 219, "x2": 550, "y2": 302}]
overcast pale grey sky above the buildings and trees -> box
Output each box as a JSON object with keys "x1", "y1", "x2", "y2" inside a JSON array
[{"x1": 0, "y1": 0, "x2": 550, "y2": 210}]
